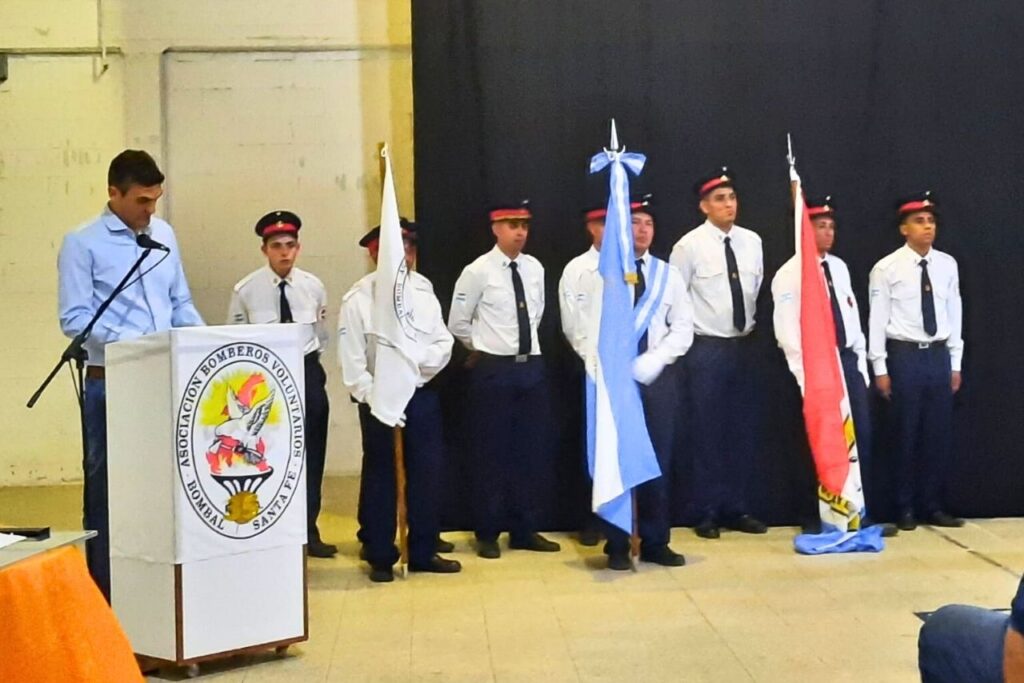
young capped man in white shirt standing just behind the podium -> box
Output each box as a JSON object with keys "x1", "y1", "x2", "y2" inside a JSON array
[{"x1": 227, "y1": 211, "x2": 338, "y2": 557}]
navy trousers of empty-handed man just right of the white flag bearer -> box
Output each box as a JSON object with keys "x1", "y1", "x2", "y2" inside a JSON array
[{"x1": 469, "y1": 354, "x2": 549, "y2": 541}]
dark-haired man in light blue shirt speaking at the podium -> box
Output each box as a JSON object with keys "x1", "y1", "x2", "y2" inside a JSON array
[{"x1": 57, "y1": 150, "x2": 204, "y2": 601}]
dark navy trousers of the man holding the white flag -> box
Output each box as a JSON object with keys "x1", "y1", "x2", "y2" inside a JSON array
[{"x1": 359, "y1": 388, "x2": 444, "y2": 568}]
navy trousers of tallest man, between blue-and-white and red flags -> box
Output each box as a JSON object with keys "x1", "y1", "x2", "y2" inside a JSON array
[{"x1": 683, "y1": 335, "x2": 759, "y2": 520}]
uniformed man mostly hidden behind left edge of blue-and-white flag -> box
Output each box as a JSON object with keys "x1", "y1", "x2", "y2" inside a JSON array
[{"x1": 558, "y1": 194, "x2": 608, "y2": 546}]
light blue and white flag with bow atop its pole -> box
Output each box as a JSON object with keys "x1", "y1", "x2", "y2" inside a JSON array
[{"x1": 587, "y1": 132, "x2": 662, "y2": 533}]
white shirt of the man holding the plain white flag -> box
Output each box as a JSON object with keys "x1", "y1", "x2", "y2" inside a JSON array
[{"x1": 338, "y1": 271, "x2": 454, "y2": 403}]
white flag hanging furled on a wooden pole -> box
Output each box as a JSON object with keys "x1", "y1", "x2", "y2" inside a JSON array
[{"x1": 370, "y1": 146, "x2": 420, "y2": 427}]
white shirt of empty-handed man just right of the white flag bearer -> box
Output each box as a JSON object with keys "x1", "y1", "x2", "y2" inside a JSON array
[{"x1": 449, "y1": 245, "x2": 544, "y2": 355}]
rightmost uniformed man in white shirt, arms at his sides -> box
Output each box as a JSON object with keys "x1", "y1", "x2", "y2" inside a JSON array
[{"x1": 867, "y1": 191, "x2": 964, "y2": 530}]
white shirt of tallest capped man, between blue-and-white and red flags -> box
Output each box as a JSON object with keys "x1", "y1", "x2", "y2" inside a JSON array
[{"x1": 669, "y1": 221, "x2": 764, "y2": 337}]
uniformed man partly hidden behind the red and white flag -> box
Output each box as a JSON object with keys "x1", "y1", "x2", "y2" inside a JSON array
[{"x1": 771, "y1": 197, "x2": 896, "y2": 536}]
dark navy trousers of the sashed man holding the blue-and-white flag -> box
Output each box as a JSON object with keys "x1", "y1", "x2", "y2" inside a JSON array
[{"x1": 604, "y1": 361, "x2": 680, "y2": 555}]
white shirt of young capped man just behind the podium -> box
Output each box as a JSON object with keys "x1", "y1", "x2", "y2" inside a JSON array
[{"x1": 227, "y1": 265, "x2": 329, "y2": 353}]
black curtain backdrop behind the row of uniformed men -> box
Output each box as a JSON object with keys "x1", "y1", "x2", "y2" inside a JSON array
[{"x1": 413, "y1": 0, "x2": 1024, "y2": 528}]
